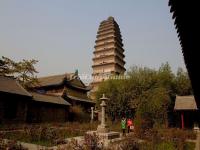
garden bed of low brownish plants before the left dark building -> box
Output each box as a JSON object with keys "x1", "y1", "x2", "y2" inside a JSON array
[{"x1": 0, "y1": 122, "x2": 97, "y2": 146}]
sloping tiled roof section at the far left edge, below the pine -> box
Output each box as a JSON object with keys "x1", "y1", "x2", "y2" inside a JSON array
[{"x1": 0, "y1": 76, "x2": 31, "y2": 97}]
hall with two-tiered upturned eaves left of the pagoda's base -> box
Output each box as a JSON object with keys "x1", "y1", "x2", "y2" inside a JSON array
[{"x1": 33, "y1": 73, "x2": 95, "y2": 112}]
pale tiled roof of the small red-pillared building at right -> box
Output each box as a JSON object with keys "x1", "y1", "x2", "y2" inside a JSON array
[{"x1": 174, "y1": 96, "x2": 197, "y2": 110}]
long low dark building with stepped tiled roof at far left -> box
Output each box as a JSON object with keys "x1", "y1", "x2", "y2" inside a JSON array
[{"x1": 0, "y1": 76, "x2": 71, "y2": 124}]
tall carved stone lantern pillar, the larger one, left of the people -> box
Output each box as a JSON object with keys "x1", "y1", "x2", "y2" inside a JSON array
[{"x1": 97, "y1": 94, "x2": 109, "y2": 133}]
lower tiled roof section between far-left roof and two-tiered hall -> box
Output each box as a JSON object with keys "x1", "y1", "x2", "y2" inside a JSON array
[{"x1": 30, "y1": 92, "x2": 71, "y2": 105}]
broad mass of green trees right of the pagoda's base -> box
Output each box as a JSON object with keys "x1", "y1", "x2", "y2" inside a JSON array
[{"x1": 97, "y1": 63, "x2": 194, "y2": 129}]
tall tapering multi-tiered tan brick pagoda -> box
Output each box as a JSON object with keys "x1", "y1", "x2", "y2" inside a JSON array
[{"x1": 92, "y1": 17, "x2": 126, "y2": 91}]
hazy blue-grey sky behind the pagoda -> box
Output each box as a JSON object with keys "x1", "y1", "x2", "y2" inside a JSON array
[{"x1": 0, "y1": 0, "x2": 185, "y2": 82}]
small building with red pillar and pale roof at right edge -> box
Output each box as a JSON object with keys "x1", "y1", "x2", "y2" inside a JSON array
[{"x1": 174, "y1": 95, "x2": 200, "y2": 129}]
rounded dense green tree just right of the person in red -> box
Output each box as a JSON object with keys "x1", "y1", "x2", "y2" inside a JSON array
[{"x1": 135, "y1": 87, "x2": 170, "y2": 130}]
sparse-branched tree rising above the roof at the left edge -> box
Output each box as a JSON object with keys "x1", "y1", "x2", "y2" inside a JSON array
[{"x1": 0, "y1": 56, "x2": 38, "y2": 88}]
